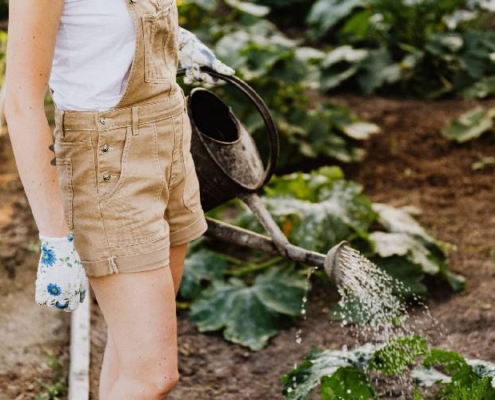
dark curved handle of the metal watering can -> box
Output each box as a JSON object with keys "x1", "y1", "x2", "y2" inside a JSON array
[{"x1": 177, "y1": 67, "x2": 280, "y2": 186}]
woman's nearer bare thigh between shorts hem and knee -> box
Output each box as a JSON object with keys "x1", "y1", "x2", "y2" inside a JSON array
[{"x1": 90, "y1": 267, "x2": 177, "y2": 379}]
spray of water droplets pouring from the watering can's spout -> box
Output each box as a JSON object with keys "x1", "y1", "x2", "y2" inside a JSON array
[{"x1": 295, "y1": 247, "x2": 443, "y2": 399}]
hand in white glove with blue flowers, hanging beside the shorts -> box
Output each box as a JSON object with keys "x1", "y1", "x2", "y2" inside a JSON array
[{"x1": 35, "y1": 233, "x2": 88, "y2": 312}]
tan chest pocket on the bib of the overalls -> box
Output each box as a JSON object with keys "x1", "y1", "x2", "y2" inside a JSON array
[{"x1": 142, "y1": 1, "x2": 178, "y2": 84}]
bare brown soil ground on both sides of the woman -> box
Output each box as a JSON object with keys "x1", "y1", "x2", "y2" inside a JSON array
[{"x1": 0, "y1": 96, "x2": 495, "y2": 400}]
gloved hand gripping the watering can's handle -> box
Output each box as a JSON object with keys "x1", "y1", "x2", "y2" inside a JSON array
[{"x1": 179, "y1": 27, "x2": 235, "y2": 84}]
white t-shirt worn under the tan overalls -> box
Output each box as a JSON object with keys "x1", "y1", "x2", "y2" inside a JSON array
[{"x1": 50, "y1": 0, "x2": 136, "y2": 111}]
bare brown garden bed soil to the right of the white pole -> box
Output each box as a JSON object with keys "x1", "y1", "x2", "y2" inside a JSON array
[{"x1": 86, "y1": 96, "x2": 495, "y2": 400}]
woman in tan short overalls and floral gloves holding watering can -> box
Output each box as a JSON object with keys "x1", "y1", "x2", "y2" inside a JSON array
[{"x1": 6, "y1": 0, "x2": 234, "y2": 400}]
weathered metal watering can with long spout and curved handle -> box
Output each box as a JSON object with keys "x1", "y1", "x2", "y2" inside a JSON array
[{"x1": 177, "y1": 68, "x2": 352, "y2": 282}]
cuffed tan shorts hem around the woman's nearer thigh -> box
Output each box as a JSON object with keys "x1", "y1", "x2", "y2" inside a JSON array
[{"x1": 81, "y1": 244, "x2": 170, "y2": 278}]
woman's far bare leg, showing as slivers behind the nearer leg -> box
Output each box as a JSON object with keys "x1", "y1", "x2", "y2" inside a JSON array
[{"x1": 95, "y1": 244, "x2": 187, "y2": 400}]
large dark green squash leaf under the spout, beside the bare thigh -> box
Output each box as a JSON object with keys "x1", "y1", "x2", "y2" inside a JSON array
[{"x1": 190, "y1": 268, "x2": 307, "y2": 350}]
